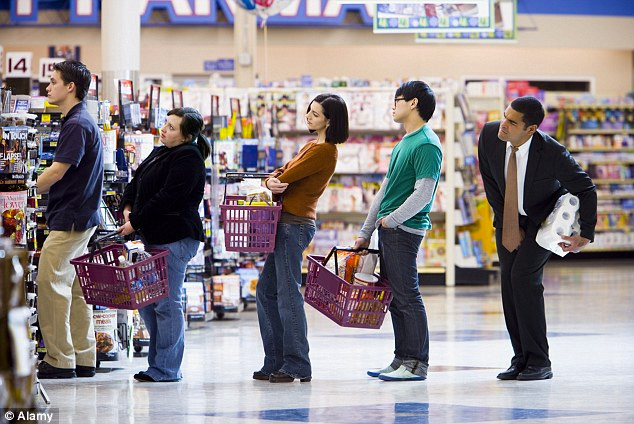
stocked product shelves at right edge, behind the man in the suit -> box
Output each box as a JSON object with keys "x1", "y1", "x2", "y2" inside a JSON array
[{"x1": 562, "y1": 99, "x2": 634, "y2": 252}]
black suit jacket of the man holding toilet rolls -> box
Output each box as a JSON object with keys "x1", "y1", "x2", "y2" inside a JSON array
[{"x1": 478, "y1": 121, "x2": 597, "y2": 241}]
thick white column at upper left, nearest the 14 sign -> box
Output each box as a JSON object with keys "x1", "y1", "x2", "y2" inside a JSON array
[{"x1": 101, "y1": 0, "x2": 141, "y2": 105}]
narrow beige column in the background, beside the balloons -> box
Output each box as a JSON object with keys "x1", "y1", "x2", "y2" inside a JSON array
[{"x1": 233, "y1": 7, "x2": 258, "y2": 88}]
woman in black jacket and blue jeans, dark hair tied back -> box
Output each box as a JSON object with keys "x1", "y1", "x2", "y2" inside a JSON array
[{"x1": 119, "y1": 107, "x2": 210, "y2": 381}]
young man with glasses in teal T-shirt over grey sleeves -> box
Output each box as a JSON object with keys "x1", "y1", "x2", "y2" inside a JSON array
[{"x1": 354, "y1": 81, "x2": 442, "y2": 381}]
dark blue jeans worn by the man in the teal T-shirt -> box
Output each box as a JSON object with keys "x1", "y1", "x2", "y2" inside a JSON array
[{"x1": 379, "y1": 227, "x2": 429, "y2": 368}]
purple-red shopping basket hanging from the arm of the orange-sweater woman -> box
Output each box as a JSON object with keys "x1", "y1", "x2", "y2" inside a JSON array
[{"x1": 220, "y1": 172, "x2": 282, "y2": 252}]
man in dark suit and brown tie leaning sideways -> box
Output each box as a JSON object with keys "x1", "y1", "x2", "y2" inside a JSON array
[{"x1": 478, "y1": 97, "x2": 597, "y2": 380}]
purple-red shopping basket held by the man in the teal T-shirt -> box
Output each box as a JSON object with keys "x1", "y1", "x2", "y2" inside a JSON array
[{"x1": 304, "y1": 247, "x2": 392, "y2": 328}]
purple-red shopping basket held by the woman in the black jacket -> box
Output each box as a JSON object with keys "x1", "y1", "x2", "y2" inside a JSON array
[{"x1": 70, "y1": 237, "x2": 169, "y2": 310}]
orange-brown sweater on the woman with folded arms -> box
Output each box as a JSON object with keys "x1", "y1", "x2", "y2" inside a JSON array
[{"x1": 267, "y1": 141, "x2": 338, "y2": 219}]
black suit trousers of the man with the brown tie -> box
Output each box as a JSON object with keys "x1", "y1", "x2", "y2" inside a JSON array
[{"x1": 495, "y1": 217, "x2": 550, "y2": 368}]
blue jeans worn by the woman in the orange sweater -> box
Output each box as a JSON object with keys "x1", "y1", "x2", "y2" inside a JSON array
[{"x1": 256, "y1": 223, "x2": 315, "y2": 378}]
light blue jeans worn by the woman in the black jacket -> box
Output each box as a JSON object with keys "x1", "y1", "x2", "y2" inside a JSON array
[{"x1": 139, "y1": 237, "x2": 200, "y2": 381}]
